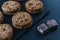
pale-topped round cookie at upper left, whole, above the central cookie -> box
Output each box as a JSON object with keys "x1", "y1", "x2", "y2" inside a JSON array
[{"x1": 2, "y1": 1, "x2": 21, "y2": 15}]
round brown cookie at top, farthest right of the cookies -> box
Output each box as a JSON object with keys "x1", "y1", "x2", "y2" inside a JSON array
[{"x1": 25, "y1": 1, "x2": 43, "y2": 14}]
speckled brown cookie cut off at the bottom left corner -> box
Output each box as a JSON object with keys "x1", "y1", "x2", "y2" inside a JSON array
[{"x1": 0, "y1": 24, "x2": 13, "y2": 40}]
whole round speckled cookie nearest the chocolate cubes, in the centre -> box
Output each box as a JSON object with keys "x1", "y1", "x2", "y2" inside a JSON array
[{"x1": 12, "y1": 12, "x2": 32, "y2": 29}]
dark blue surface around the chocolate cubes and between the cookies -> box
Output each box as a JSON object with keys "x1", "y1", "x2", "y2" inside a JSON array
[{"x1": 0, "y1": 0, "x2": 60, "y2": 40}]
